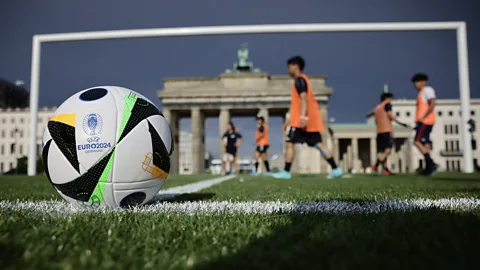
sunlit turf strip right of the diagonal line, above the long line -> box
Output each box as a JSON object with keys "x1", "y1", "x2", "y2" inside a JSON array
[{"x1": 202, "y1": 173, "x2": 480, "y2": 201}]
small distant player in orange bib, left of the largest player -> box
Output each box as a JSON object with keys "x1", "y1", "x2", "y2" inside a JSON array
[{"x1": 252, "y1": 116, "x2": 271, "y2": 176}]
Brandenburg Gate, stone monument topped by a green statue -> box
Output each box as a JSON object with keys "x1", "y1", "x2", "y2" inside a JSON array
[{"x1": 158, "y1": 45, "x2": 332, "y2": 173}]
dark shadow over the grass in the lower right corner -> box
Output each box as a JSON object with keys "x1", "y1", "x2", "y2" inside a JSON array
[{"x1": 196, "y1": 210, "x2": 480, "y2": 270}]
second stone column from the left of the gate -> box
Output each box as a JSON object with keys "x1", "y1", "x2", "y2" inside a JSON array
[{"x1": 191, "y1": 107, "x2": 205, "y2": 174}]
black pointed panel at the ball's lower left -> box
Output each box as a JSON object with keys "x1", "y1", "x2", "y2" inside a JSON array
[{"x1": 54, "y1": 151, "x2": 114, "y2": 202}]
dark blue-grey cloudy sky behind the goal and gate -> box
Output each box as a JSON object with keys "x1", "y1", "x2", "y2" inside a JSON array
[{"x1": 0, "y1": 0, "x2": 480, "y2": 156}]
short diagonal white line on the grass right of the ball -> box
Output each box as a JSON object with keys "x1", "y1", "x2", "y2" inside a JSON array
[{"x1": 152, "y1": 175, "x2": 235, "y2": 202}]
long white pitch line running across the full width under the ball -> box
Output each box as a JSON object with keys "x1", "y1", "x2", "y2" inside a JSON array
[{"x1": 0, "y1": 198, "x2": 480, "y2": 215}]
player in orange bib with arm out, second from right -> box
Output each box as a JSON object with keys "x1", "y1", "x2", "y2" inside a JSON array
[{"x1": 372, "y1": 93, "x2": 408, "y2": 176}]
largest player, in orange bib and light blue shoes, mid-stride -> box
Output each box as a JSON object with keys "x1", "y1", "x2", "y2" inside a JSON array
[{"x1": 272, "y1": 56, "x2": 343, "y2": 179}]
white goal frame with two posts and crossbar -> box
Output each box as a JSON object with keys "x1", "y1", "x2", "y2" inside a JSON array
[{"x1": 28, "y1": 21, "x2": 473, "y2": 176}]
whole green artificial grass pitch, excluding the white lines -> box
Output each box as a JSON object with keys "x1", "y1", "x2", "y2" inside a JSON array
[{"x1": 0, "y1": 174, "x2": 480, "y2": 270}]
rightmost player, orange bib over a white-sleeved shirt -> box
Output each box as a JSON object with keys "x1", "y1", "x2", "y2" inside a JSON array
[{"x1": 412, "y1": 73, "x2": 440, "y2": 176}]
